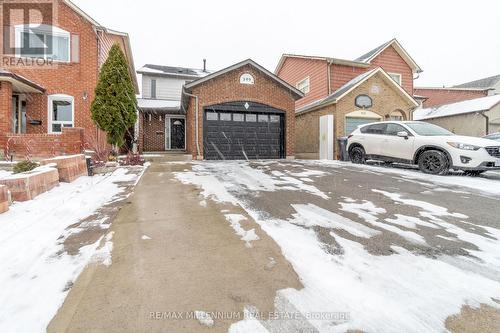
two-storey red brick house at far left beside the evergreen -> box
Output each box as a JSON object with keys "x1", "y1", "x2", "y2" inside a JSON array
[{"x1": 0, "y1": 0, "x2": 139, "y2": 158}]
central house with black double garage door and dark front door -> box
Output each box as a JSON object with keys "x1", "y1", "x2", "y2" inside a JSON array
[{"x1": 139, "y1": 59, "x2": 304, "y2": 160}]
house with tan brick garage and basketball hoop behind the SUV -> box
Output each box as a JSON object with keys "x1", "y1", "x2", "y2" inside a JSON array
[{"x1": 275, "y1": 39, "x2": 422, "y2": 158}]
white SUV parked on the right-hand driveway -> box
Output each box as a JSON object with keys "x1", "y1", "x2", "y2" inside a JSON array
[{"x1": 347, "y1": 121, "x2": 500, "y2": 175}]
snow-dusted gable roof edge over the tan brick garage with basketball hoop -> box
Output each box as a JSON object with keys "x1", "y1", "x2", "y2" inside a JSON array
[{"x1": 296, "y1": 67, "x2": 419, "y2": 113}]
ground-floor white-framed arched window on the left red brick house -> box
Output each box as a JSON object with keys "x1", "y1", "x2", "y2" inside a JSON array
[{"x1": 48, "y1": 95, "x2": 75, "y2": 133}]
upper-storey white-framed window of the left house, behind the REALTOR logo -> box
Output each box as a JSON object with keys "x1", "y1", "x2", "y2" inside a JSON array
[{"x1": 15, "y1": 24, "x2": 71, "y2": 62}]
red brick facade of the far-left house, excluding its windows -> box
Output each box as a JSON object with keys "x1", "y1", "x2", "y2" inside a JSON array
[{"x1": 0, "y1": 0, "x2": 131, "y2": 149}]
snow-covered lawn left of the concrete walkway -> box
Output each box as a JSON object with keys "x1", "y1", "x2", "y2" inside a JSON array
[{"x1": 0, "y1": 169, "x2": 145, "y2": 332}]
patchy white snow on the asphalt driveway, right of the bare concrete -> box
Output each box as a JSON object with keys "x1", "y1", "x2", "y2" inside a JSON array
[{"x1": 176, "y1": 161, "x2": 500, "y2": 332}]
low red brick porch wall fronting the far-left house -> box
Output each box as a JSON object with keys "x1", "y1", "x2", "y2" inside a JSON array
[{"x1": 5, "y1": 128, "x2": 85, "y2": 160}]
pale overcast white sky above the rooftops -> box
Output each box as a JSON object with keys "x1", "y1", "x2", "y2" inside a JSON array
[{"x1": 73, "y1": 0, "x2": 500, "y2": 86}]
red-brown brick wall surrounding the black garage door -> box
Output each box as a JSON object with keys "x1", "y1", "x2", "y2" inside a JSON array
[{"x1": 186, "y1": 65, "x2": 295, "y2": 158}]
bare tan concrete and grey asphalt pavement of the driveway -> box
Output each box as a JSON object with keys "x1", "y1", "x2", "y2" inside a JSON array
[{"x1": 49, "y1": 161, "x2": 500, "y2": 332}]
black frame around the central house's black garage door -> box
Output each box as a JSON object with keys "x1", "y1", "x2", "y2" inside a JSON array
[{"x1": 203, "y1": 101, "x2": 287, "y2": 159}]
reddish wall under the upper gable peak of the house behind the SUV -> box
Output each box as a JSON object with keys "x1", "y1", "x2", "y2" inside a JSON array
[{"x1": 371, "y1": 46, "x2": 413, "y2": 95}]
